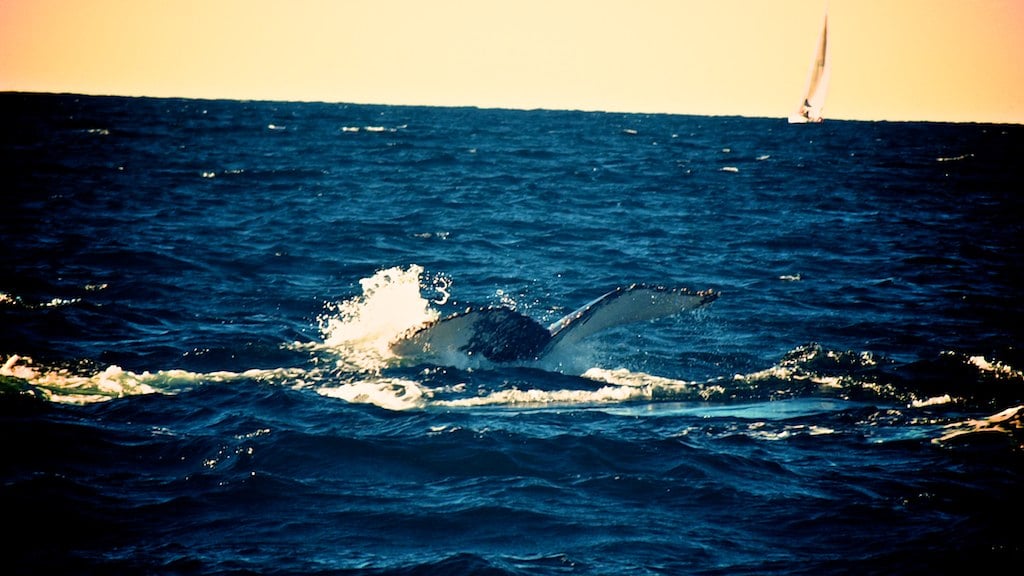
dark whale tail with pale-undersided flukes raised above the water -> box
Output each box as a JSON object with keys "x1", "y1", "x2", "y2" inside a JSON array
[{"x1": 389, "y1": 284, "x2": 720, "y2": 363}]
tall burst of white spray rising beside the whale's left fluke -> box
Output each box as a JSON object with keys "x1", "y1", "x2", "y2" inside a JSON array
[{"x1": 319, "y1": 264, "x2": 442, "y2": 374}]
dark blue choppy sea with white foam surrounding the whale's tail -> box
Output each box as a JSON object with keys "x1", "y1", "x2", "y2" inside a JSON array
[{"x1": 0, "y1": 93, "x2": 1024, "y2": 575}]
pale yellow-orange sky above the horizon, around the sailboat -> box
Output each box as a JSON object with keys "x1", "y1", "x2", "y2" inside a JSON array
[{"x1": 0, "y1": 0, "x2": 1024, "y2": 124}]
